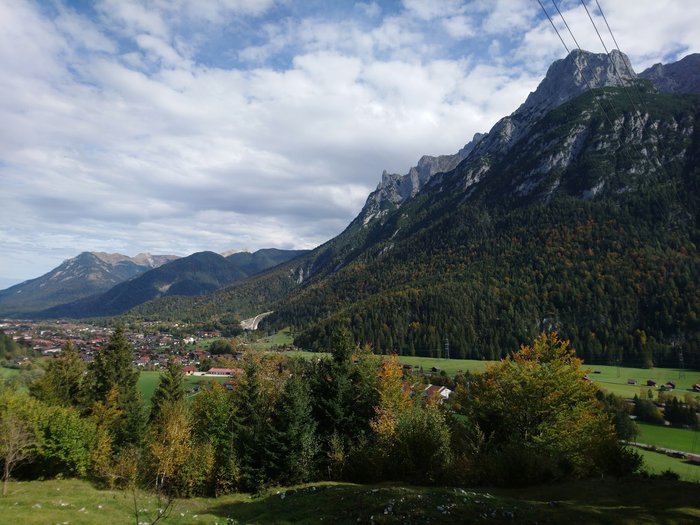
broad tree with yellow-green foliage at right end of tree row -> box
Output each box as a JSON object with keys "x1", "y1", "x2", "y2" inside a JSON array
[{"x1": 468, "y1": 333, "x2": 633, "y2": 483}]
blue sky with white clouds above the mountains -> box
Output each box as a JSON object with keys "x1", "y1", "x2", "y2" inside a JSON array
[{"x1": 0, "y1": 0, "x2": 700, "y2": 289}]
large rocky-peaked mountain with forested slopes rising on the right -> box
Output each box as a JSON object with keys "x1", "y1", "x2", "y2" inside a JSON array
[{"x1": 123, "y1": 52, "x2": 700, "y2": 367}]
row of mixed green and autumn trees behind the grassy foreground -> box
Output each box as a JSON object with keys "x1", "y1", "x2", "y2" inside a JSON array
[{"x1": 0, "y1": 327, "x2": 640, "y2": 497}]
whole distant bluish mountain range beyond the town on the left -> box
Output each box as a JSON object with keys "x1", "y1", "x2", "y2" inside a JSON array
[{"x1": 0, "y1": 249, "x2": 305, "y2": 318}]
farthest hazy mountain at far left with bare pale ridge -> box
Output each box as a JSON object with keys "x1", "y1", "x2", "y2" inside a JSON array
[{"x1": 0, "y1": 252, "x2": 177, "y2": 316}]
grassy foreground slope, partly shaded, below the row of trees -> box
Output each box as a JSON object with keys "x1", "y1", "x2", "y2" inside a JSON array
[{"x1": 0, "y1": 479, "x2": 700, "y2": 525}]
